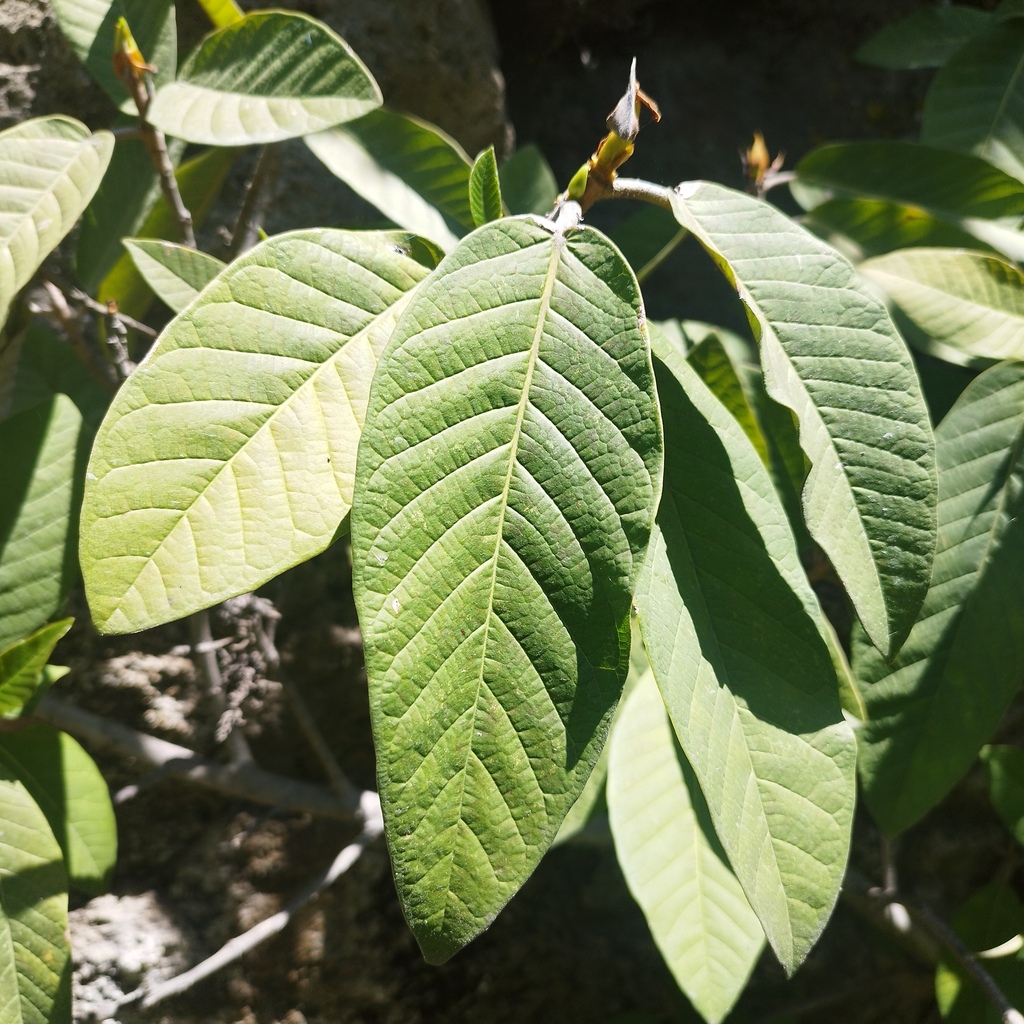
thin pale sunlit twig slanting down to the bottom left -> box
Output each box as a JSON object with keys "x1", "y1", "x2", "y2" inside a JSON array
[{"x1": 118, "y1": 792, "x2": 384, "y2": 1009}]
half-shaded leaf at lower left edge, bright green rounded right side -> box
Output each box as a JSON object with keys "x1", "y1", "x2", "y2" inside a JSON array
[{"x1": 0, "y1": 725, "x2": 118, "y2": 895}]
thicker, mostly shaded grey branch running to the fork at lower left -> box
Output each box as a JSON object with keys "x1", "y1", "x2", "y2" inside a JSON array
[{"x1": 35, "y1": 693, "x2": 366, "y2": 821}]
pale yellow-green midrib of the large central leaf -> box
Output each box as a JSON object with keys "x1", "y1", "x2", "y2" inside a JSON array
[{"x1": 441, "y1": 232, "x2": 565, "y2": 927}]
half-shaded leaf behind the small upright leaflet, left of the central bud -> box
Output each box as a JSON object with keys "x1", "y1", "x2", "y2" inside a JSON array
[{"x1": 305, "y1": 110, "x2": 474, "y2": 250}]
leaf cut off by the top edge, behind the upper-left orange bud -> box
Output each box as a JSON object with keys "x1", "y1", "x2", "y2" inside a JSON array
[{"x1": 52, "y1": 0, "x2": 178, "y2": 113}]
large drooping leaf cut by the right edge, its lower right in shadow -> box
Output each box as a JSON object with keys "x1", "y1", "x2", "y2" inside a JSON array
[{"x1": 853, "y1": 362, "x2": 1024, "y2": 835}]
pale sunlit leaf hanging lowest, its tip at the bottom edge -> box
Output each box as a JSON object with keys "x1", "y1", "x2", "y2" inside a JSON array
[{"x1": 608, "y1": 673, "x2": 764, "y2": 1024}]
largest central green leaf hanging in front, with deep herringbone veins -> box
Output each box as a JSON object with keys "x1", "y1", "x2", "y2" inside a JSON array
[{"x1": 352, "y1": 217, "x2": 662, "y2": 963}]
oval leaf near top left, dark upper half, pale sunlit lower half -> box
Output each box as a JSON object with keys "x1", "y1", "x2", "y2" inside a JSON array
[{"x1": 148, "y1": 10, "x2": 381, "y2": 145}]
